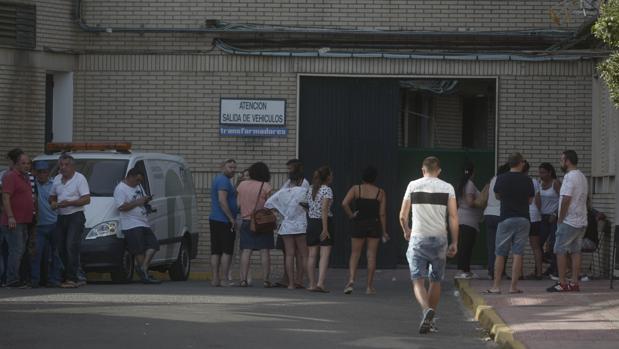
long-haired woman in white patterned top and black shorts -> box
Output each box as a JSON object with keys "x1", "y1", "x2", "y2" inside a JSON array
[{"x1": 306, "y1": 166, "x2": 334, "y2": 293}]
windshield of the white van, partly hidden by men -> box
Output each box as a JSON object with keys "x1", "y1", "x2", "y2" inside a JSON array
[{"x1": 46, "y1": 159, "x2": 129, "y2": 196}]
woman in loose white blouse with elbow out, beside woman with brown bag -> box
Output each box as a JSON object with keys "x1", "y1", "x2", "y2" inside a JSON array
[{"x1": 264, "y1": 171, "x2": 307, "y2": 290}]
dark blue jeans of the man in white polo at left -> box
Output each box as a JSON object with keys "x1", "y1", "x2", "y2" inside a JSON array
[{"x1": 52, "y1": 211, "x2": 86, "y2": 282}]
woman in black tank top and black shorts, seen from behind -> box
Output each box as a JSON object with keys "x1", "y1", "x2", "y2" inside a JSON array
[{"x1": 342, "y1": 166, "x2": 389, "y2": 294}]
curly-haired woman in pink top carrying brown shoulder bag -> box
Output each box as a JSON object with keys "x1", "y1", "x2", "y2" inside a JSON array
[{"x1": 237, "y1": 162, "x2": 273, "y2": 288}]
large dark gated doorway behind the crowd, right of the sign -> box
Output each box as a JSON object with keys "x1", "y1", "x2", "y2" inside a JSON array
[{"x1": 299, "y1": 76, "x2": 496, "y2": 268}]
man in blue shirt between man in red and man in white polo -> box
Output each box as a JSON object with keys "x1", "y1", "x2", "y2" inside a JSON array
[{"x1": 30, "y1": 161, "x2": 62, "y2": 287}]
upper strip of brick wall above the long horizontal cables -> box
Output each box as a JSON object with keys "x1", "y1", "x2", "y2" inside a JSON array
[{"x1": 83, "y1": 0, "x2": 582, "y2": 31}]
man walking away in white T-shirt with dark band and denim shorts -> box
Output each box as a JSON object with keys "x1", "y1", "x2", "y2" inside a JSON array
[{"x1": 400, "y1": 156, "x2": 458, "y2": 334}]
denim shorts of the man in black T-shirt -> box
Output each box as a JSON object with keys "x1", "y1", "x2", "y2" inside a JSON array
[{"x1": 494, "y1": 217, "x2": 531, "y2": 257}]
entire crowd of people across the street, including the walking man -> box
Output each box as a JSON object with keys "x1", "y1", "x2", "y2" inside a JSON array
[{"x1": 0, "y1": 145, "x2": 599, "y2": 333}]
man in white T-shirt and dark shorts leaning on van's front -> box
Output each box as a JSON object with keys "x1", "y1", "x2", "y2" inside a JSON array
[{"x1": 114, "y1": 167, "x2": 161, "y2": 284}]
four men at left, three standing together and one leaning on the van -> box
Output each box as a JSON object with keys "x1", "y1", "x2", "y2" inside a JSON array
[{"x1": 0, "y1": 148, "x2": 159, "y2": 288}]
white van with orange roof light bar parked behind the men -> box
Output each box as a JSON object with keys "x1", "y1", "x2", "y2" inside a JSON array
[{"x1": 33, "y1": 143, "x2": 198, "y2": 282}]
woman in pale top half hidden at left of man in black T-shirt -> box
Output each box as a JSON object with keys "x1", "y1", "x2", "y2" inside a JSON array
[{"x1": 482, "y1": 164, "x2": 509, "y2": 279}]
